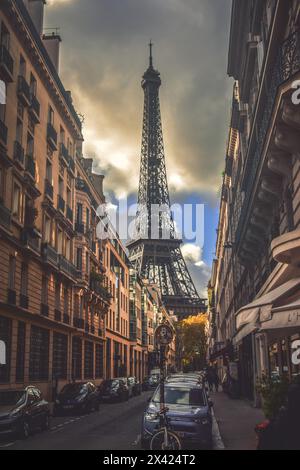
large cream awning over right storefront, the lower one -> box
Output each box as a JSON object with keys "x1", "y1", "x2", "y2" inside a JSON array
[{"x1": 233, "y1": 278, "x2": 300, "y2": 345}]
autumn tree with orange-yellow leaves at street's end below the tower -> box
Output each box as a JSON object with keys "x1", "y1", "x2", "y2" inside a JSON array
[{"x1": 176, "y1": 314, "x2": 208, "y2": 370}]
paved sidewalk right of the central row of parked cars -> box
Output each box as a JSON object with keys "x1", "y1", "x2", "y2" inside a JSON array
[{"x1": 210, "y1": 392, "x2": 265, "y2": 450}]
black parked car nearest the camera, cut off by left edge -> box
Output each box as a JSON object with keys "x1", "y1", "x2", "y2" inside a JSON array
[{"x1": 0, "y1": 386, "x2": 50, "y2": 439}]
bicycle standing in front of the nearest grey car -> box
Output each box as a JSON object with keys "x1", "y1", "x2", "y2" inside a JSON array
[{"x1": 150, "y1": 408, "x2": 182, "y2": 450}]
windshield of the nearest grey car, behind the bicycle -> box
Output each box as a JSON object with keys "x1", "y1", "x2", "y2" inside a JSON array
[{"x1": 153, "y1": 387, "x2": 205, "y2": 406}]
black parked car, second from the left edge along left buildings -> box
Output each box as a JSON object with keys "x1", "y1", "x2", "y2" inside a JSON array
[{"x1": 54, "y1": 382, "x2": 99, "y2": 415}]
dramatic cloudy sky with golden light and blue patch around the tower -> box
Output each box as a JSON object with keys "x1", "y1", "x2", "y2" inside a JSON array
[{"x1": 46, "y1": 0, "x2": 232, "y2": 294}]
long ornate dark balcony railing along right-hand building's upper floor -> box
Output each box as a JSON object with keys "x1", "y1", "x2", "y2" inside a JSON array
[{"x1": 235, "y1": 31, "x2": 300, "y2": 248}]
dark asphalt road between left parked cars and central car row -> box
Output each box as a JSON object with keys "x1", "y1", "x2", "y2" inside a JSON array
[{"x1": 0, "y1": 392, "x2": 152, "y2": 450}]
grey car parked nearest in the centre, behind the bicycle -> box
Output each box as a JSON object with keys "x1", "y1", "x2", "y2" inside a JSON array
[{"x1": 142, "y1": 382, "x2": 212, "y2": 449}]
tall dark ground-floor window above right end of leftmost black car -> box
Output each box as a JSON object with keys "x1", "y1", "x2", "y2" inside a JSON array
[{"x1": 29, "y1": 325, "x2": 49, "y2": 381}]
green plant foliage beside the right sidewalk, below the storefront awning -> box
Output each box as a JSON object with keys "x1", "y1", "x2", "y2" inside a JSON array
[{"x1": 257, "y1": 375, "x2": 289, "y2": 419}]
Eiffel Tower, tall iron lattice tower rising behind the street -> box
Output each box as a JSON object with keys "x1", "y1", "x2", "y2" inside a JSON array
[{"x1": 127, "y1": 42, "x2": 205, "y2": 319}]
